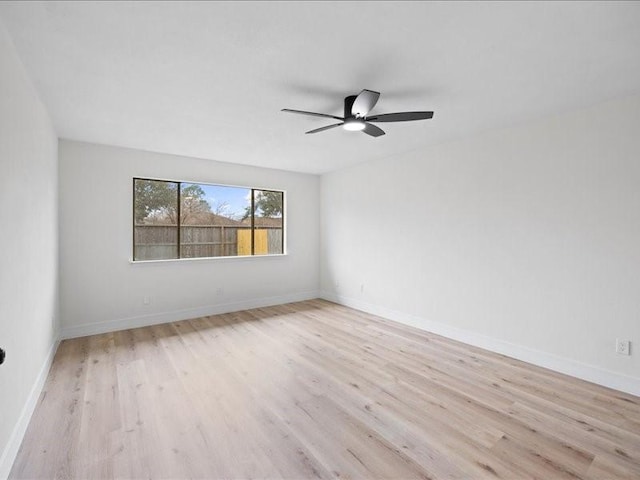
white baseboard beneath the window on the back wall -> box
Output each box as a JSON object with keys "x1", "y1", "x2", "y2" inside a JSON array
[{"x1": 61, "y1": 291, "x2": 320, "y2": 339}]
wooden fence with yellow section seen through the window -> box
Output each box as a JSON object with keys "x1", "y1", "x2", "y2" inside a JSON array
[{"x1": 134, "y1": 225, "x2": 283, "y2": 260}]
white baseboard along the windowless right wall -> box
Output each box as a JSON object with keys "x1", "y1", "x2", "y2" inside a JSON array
[{"x1": 321, "y1": 292, "x2": 640, "y2": 396}]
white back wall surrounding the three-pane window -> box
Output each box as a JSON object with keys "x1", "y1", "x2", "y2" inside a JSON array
[{"x1": 59, "y1": 140, "x2": 320, "y2": 337}]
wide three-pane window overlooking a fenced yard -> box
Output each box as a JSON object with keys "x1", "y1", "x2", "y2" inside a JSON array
[{"x1": 133, "y1": 178, "x2": 284, "y2": 261}]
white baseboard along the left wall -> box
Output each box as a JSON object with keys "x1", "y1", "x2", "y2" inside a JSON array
[{"x1": 0, "y1": 338, "x2": 60, "y2": 479}]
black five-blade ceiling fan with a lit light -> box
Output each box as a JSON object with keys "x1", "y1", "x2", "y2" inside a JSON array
[{"x1": 282, "y1": 90, "x2": 433, "y2": 137}]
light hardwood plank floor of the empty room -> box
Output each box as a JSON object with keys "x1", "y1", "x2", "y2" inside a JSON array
[{"x1": 10, "y1": 300, "x2": 640, "y2": 480}]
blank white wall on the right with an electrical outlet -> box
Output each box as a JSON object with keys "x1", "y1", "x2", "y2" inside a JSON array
[{"x1": 321, "y1": 92, "x2": 640, "y2": 394}]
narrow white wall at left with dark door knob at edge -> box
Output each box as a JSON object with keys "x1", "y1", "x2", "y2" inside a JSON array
[{"x1": 0, "y1": 19, "x2": 58, "y2": 478}]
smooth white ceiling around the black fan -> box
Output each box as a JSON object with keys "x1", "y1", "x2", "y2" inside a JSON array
[{"x1": 0, "y1": 1, "x2": 640, "y2": 173}]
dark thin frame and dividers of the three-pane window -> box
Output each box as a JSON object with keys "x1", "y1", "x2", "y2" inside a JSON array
[{"x1": 129, "y1": 176, "x2": 287, "y2": 264}]
